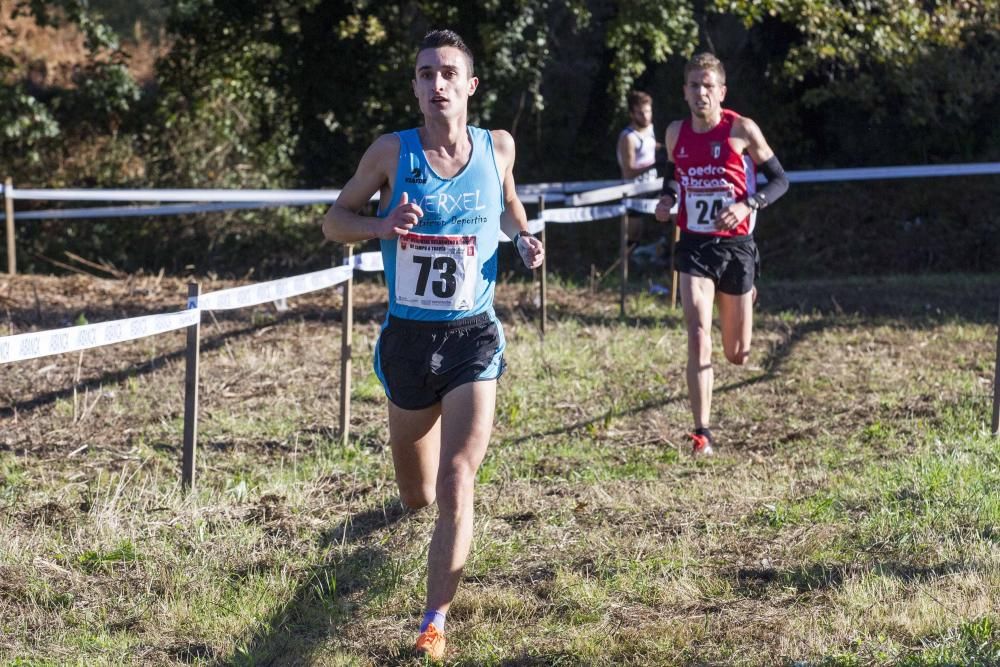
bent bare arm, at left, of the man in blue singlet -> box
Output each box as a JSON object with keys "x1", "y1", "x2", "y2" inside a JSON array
[{"x1": 323, "y1": 134, "x2": 423, "y2": 243}]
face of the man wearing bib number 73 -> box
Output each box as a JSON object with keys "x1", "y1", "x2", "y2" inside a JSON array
[{"x1": 413, "y1": 46, "x2": 479, "y2": 118}]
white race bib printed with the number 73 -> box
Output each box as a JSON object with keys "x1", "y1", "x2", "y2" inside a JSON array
[{"x1": 396, "y1": 232, "x2": 479, "y2": 310}]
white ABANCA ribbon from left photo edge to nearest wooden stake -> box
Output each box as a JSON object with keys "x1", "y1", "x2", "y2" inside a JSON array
[{"x1": 0, "y1": 310, "x2": 201, "y2": 364}]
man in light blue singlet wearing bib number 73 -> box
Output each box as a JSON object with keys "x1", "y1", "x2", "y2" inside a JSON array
[{"x1": 323, "y1": 30, "x2": 544, "y2": 660}]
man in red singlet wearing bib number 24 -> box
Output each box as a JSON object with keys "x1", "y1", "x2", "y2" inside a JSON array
[{"x1": 656, "y1": 53, "x2": 788, "y2": 454}]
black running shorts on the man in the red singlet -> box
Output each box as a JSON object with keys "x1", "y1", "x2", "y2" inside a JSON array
[{"x1": 674, "y1": 233, "x2": 760, "y2": 296}]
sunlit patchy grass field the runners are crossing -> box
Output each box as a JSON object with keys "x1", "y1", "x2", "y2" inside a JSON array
[{"x1": 0, "y1": 275, "x2": 1000, "y2": 666}]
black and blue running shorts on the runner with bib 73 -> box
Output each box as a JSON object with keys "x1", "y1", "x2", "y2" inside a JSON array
[{"x1": 375, "y1": 313, "x2": 506, "y2": 410}]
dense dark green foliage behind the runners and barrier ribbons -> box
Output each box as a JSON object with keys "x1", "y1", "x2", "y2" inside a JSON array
[{"x1": 0, "y1": 0, "x2": 1000, "y2": 270}]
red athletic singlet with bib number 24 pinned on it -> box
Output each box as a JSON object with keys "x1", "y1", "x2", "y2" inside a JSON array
[{"x1": 673, "y1": 109, "x2": 757, "y2": 236}]
